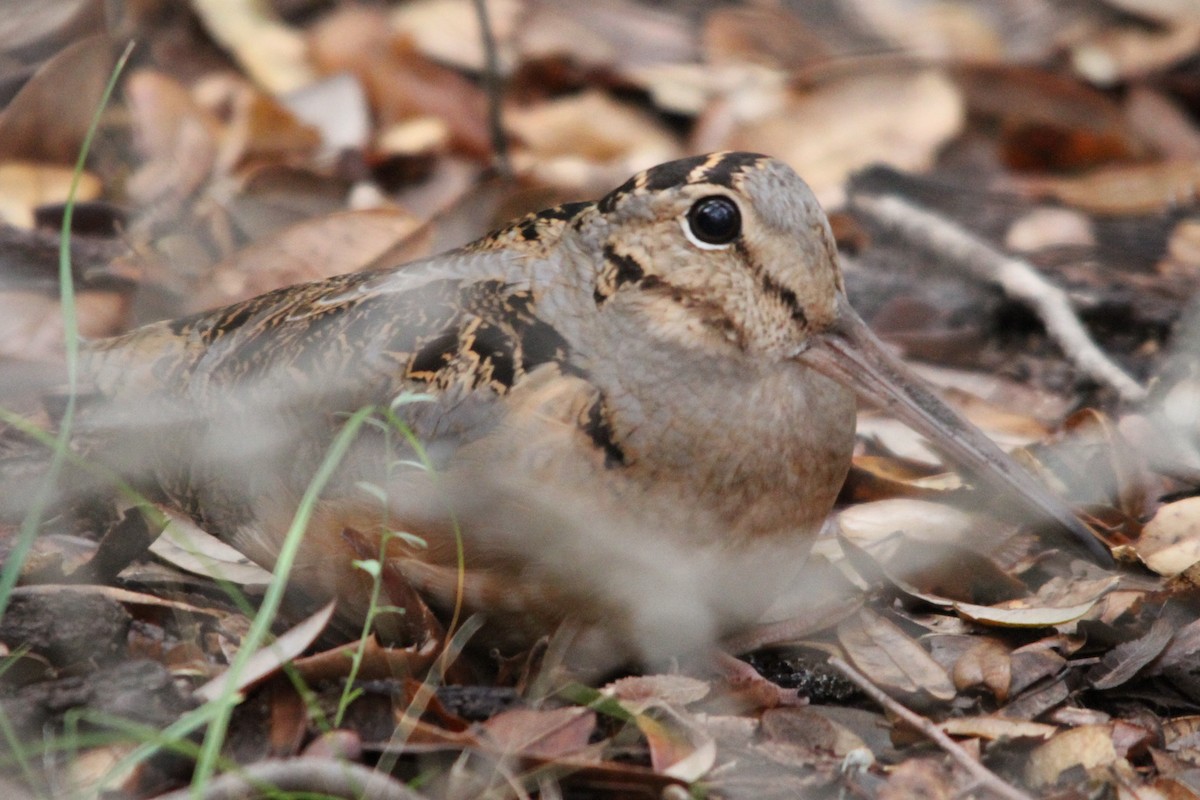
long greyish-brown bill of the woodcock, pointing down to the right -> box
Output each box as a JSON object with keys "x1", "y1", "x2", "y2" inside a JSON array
[{"x1": 798, "y1": 293, "x2": 1112, "y2": 565}]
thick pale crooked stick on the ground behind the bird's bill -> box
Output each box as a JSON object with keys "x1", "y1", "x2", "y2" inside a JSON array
[{"x1": 853, "y1": 194, "x2": 1146, "y2": 403}]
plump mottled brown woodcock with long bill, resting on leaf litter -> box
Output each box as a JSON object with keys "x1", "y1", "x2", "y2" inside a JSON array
[{"x1": 72, "y1": 152, "x2": 1106, "y2": 657}]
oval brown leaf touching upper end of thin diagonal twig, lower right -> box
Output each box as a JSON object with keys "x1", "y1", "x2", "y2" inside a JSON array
[{"x1": 838, "y1": 609, "x2": 955, "y2": 702}]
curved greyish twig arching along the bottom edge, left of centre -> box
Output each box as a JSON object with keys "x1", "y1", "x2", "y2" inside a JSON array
[{"x1": 157, "y1": 757, "x2": 421, "y2": 800}]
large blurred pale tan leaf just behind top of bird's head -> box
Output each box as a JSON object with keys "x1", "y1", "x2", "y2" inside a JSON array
[{"x1": 719, "y1": 70, "x2": 965, "y2": 206}]
